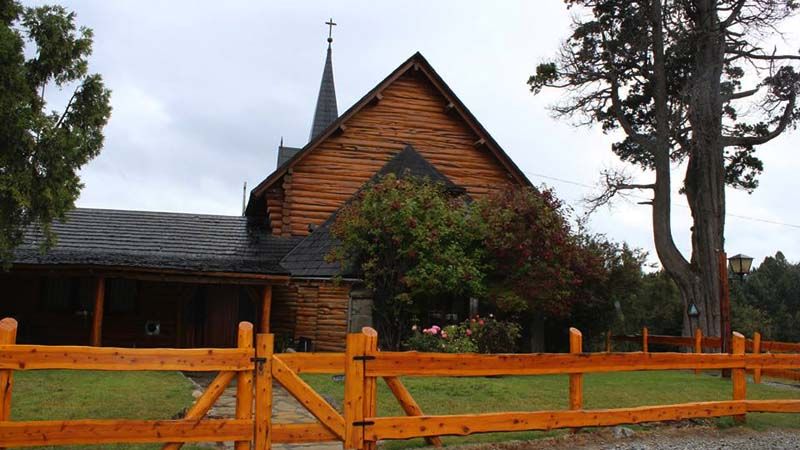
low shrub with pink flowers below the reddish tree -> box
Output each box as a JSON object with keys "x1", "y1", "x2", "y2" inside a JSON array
[{"x1": 405, "y1": 314, "x2": 520, "y2": 353}]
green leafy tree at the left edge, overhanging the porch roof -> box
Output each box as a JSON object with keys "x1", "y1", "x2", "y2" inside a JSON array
[{"x1": 0, "y1": 0, "x2": 111, "y2": 265}]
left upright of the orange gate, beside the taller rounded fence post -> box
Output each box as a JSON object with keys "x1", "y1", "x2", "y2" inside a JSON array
[{"x1": 253, "y1": 333, "x2": 275, "y2": 450}]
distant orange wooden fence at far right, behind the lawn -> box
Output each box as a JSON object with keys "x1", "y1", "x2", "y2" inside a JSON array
[{"x1": 606, "y1": 327, "x2": 800, "y2": 383}]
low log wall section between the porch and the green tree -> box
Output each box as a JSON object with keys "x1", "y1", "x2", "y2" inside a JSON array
[{"x1": 270, "y1": 280, "x2": 350, "y2": 351}]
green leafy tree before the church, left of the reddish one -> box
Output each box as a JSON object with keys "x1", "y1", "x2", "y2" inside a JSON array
[{"x1": 330, "y1": 174, "x2": 485, "y2": 349}]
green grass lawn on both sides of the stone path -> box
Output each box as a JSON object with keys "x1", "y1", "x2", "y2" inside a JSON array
[{"x1": 7, "y1": 370, "x2": 800, "y2": 449}]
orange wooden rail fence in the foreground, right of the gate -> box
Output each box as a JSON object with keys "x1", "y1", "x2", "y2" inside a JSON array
[{"x1": 356, "y1": 329, "x2": 800, "y2": 442}]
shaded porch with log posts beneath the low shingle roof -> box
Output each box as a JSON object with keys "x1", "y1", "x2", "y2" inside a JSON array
[{"x1": 0, "y1": 268, "x2": 287, "y2": 348}]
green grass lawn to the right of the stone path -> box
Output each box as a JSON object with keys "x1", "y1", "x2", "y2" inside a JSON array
[{"x1": 304, "y1": 371, "x2": 800, "y2": 449}]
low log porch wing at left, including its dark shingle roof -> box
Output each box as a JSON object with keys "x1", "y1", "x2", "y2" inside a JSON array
[{"x1": 0, "y1": 208, "x2": 297, "y2": 348}]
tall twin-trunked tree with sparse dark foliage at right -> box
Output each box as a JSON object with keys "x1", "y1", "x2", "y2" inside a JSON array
[{"x1": 529, "y1": 0, "x2": 800, "y2": 344}]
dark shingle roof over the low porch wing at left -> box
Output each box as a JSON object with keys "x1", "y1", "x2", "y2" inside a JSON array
[{"x1": 14, "y1": 208, "x2": 301, "y2": 274}]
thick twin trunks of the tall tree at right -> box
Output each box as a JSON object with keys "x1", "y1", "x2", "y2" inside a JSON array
[{"x1": 652, "y1": 0, "x2": 725, "y2": 342}]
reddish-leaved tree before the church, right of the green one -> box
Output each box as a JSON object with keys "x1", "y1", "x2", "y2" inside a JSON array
[{"x1": 477, "y1": 188, "x2": 605, "y2": 351}]
